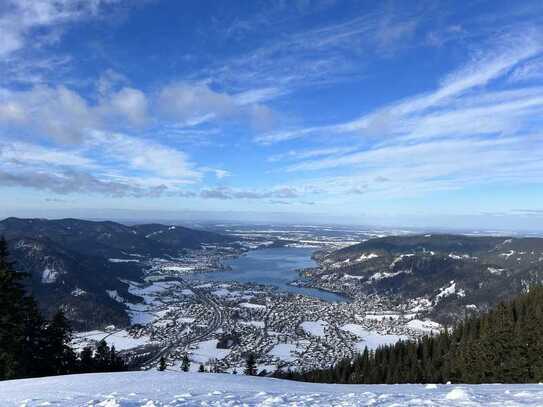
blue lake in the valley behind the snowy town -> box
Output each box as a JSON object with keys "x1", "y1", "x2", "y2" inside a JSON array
[{"x1": 190, "y1": 247, "x2": 346, "y2": 302}]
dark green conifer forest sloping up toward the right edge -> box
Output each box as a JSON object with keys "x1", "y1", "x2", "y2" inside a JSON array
[{"x1": 276, "y1": 286, "x2": 543, "y2": 384}]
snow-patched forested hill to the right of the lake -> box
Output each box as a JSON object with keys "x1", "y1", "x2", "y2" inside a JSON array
[{"x1": 307, "y1": 234, "x2": 543, "y2": 324}]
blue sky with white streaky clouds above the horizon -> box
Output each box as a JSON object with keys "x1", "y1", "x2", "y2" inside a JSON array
[{"x1": 0, "y1": 0, "x2": 543, "y2": 231}]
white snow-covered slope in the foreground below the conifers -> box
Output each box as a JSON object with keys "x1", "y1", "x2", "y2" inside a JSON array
[{"x1": 0, "y1": 371, "x2": 543, "y2": 407}]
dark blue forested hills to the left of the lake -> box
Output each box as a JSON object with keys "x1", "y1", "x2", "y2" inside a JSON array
[{"x1": 0, "y1": 218, "x2": 231, "y2": 329}]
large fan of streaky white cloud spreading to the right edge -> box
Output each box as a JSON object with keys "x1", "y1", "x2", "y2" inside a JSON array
[{"x1": 266, "y1": 32, "x2": 543, "y2": 201}]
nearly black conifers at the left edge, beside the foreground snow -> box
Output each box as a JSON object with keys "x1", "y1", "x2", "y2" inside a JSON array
[{"x1": 0, "y1": 238, "x2": 125, "y2": 380}]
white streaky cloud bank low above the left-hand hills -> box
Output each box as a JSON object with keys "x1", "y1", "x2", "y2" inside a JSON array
[{"x1": 0, "y1": 131, "x2": 204, "y2": 197}]
